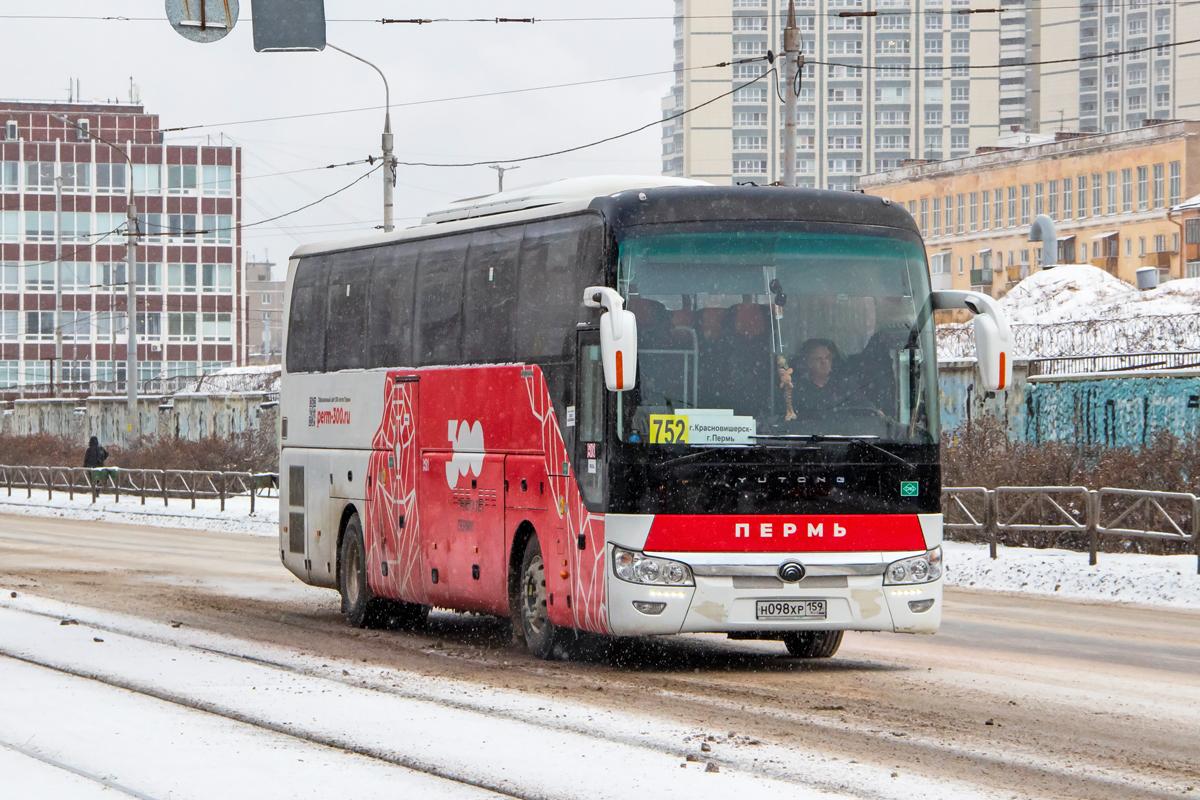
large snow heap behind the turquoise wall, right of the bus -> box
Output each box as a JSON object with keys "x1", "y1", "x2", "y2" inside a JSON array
[{"x1": 937, "y1": 264, "x2": 1200, "y2": 360}]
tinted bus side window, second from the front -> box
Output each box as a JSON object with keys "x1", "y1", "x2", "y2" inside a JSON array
[{"x1": 462, "y1": 227, "x2": 524, "y2": 363}]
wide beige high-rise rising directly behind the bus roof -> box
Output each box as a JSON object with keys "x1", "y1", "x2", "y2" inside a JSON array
[{"x1": 662, "y1": 0, "x2": 1003, "y2": 188}]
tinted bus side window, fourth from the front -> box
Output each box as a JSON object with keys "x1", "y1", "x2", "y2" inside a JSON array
[{"x1": 368, "y1": 242, "x2": 420, "y2": 367}]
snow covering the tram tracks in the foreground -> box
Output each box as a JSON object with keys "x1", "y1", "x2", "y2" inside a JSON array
[{"x1": 0, "y1": 591, "x2": 995, "y2": 800}]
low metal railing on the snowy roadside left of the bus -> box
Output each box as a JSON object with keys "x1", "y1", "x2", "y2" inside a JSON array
[{"x1": 0, "y1": 464, "x2": 280, "y2": 513}]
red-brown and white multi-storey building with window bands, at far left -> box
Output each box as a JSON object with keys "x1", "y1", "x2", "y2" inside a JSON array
[{"x1": 0, "y1": 102, "x2": 246, "y2": 396}]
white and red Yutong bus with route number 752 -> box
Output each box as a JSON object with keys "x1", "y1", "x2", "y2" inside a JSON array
[{"x1": 280, "y1": 178, "x2": 1010, "y2": 657}]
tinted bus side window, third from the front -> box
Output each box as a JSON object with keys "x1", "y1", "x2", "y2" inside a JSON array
[{"x1": 413, "y1": 236, "x2": 468, "y2": 366}]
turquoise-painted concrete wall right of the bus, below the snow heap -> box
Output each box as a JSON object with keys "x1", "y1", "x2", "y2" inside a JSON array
[{"x1": 938, "y1": 363, "x2": 1200, "y2": 447}]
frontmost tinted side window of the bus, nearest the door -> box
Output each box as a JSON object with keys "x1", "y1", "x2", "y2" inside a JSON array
[{"x1": 516, "y1": 217, "x2": 601, "y2": 359}]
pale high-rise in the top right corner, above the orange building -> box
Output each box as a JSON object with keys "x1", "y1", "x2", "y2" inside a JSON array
[{"x1": 1027, "y1": 0, "x2": 1200, "y2": 133}]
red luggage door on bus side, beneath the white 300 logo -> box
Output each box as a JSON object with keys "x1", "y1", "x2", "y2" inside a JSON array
[{"x1": 419, "y1": 451, "x2": 508, "y2": 614}]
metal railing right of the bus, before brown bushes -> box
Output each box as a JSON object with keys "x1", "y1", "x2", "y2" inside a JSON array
[{"x1": 942, "y1": 486, "x2": 1200, "y2": 573}]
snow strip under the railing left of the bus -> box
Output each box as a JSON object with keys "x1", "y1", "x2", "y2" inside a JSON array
[{"x1": 0, "y1": 489, "x2": 280, "y2": 536}]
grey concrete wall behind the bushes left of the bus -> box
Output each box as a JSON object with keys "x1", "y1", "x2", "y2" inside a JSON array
[{"x1": 0, "y1": 392, "x2": 277, "y2": 445}]
